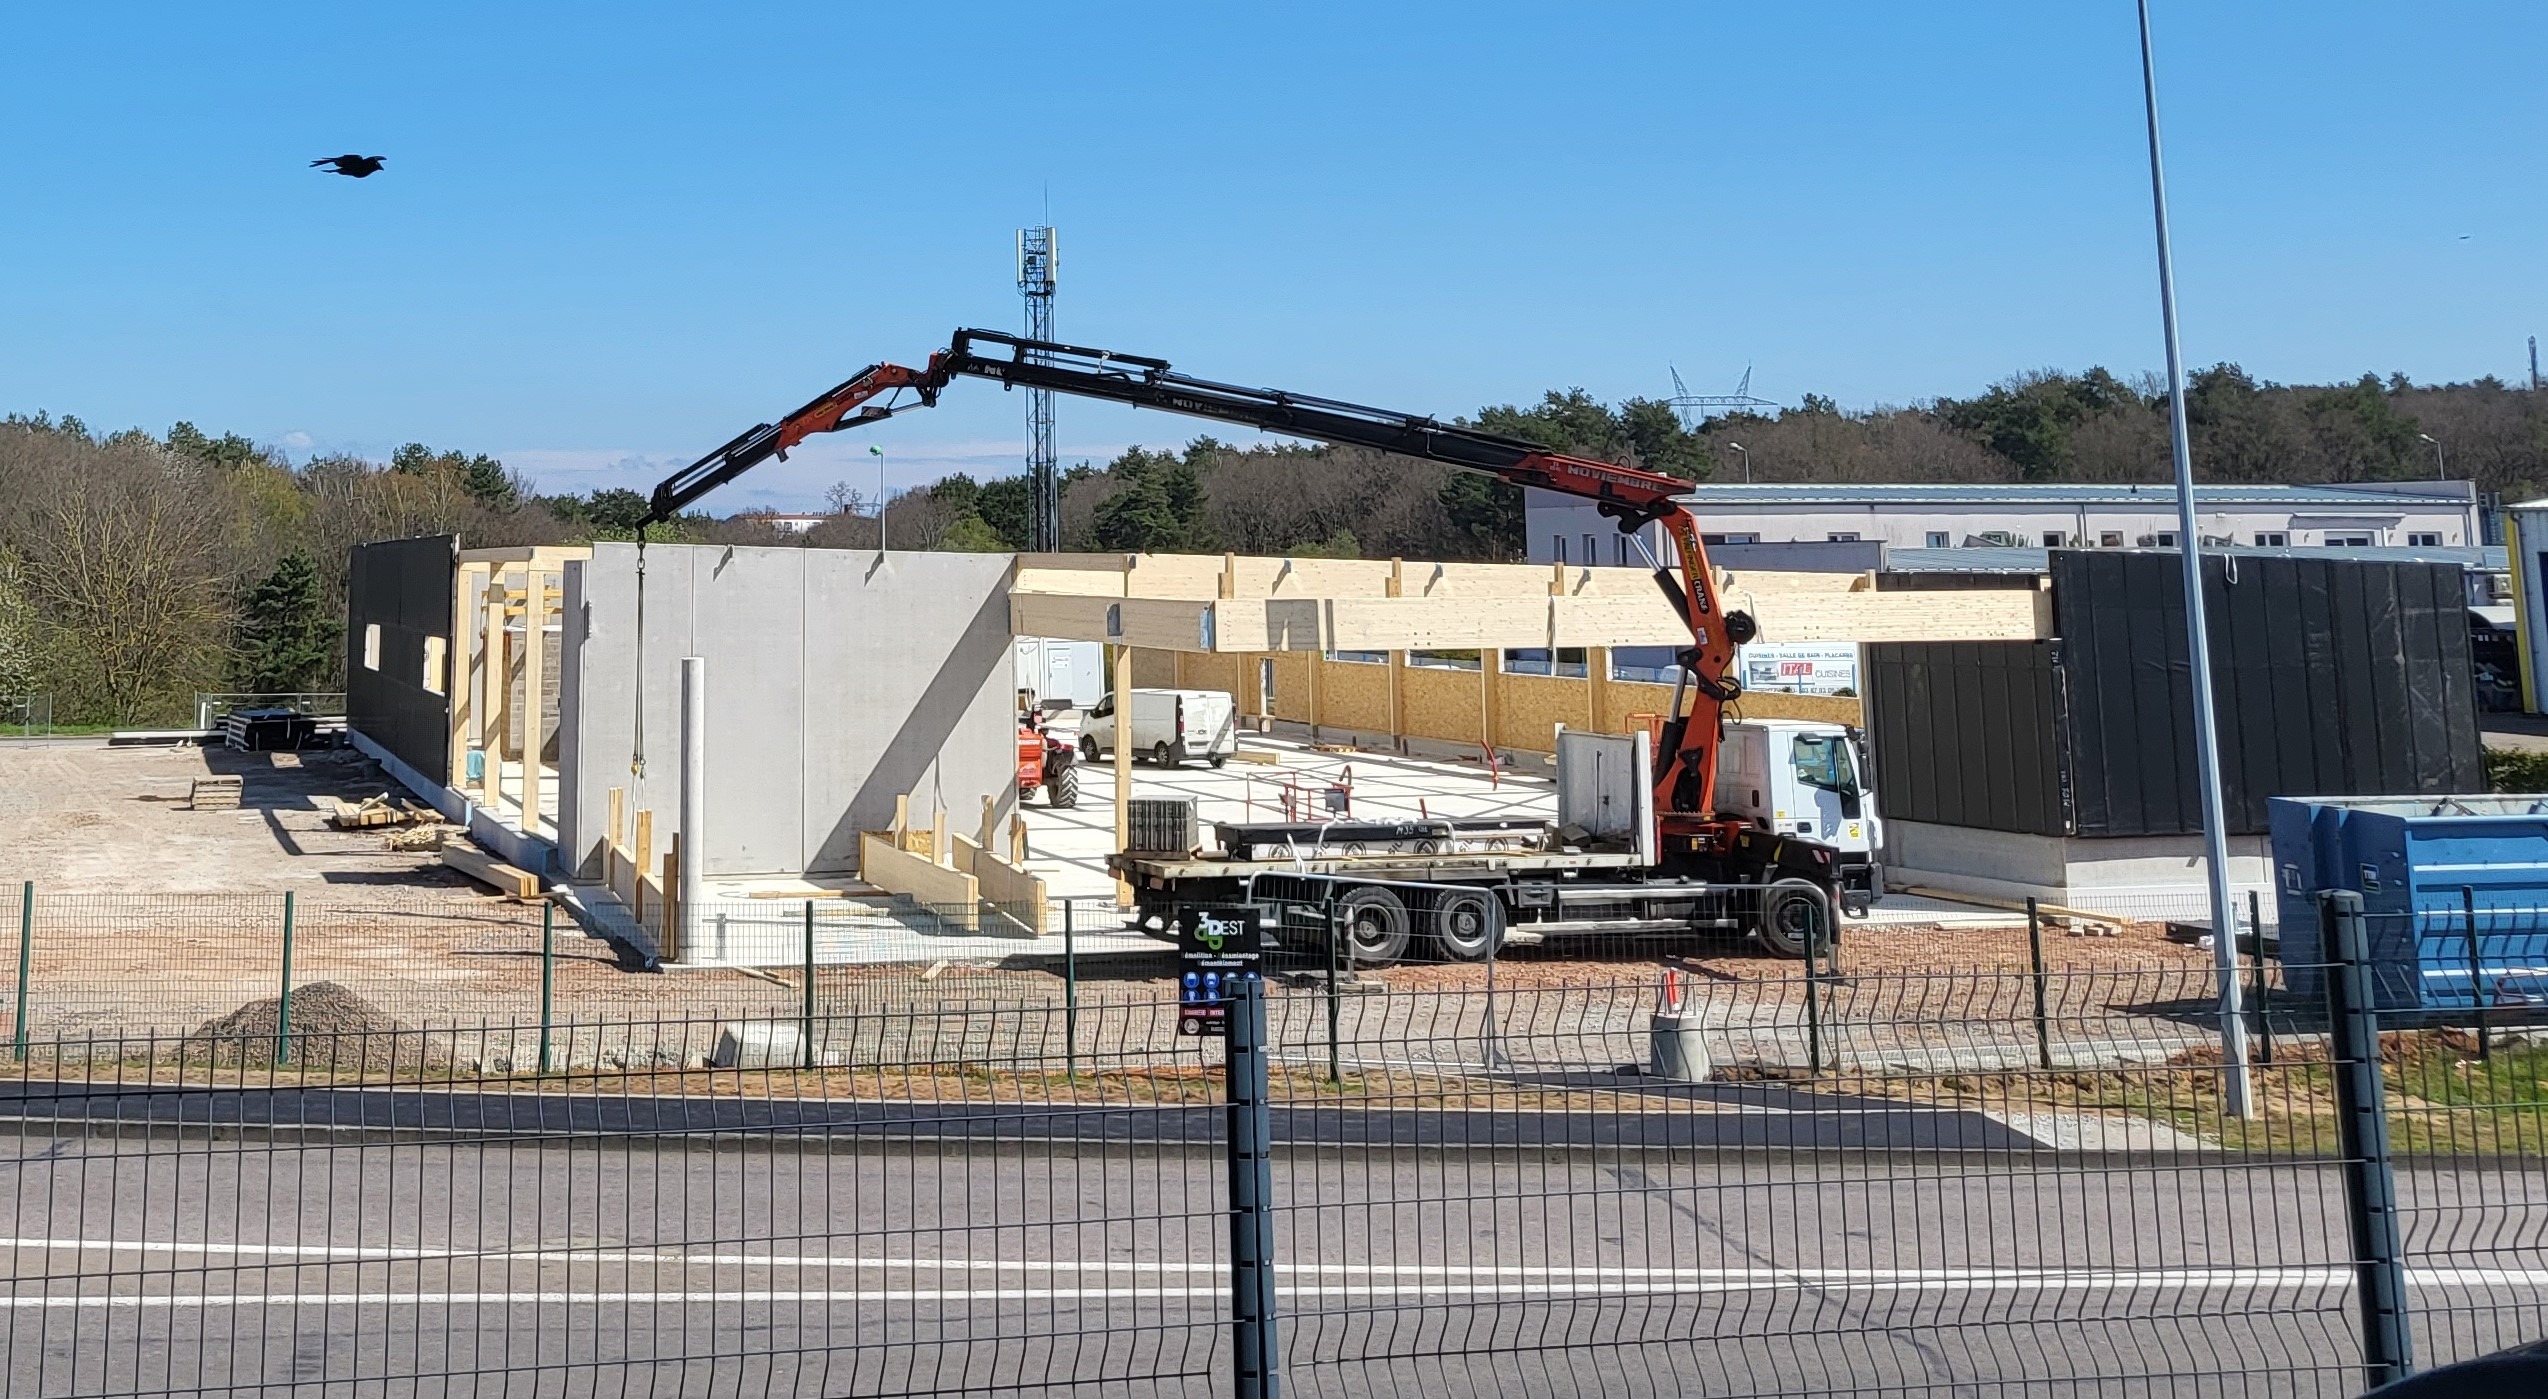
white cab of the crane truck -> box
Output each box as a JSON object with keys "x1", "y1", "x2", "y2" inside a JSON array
[{"x1": 1717, "y1": 719, "x2": 1883, "y2": 902}]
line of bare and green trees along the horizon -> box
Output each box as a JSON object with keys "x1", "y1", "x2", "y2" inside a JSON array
[{"x1": 0, "y1": 364, "x2": 2548, "y2": 724}]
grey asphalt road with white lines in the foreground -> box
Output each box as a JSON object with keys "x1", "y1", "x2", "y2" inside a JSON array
[{"x1": 0, "y1": 1121, "x2": 2548, "y2": 1399}]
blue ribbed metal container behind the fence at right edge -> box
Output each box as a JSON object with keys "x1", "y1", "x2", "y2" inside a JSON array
[{"x1": 2268, "y1": 795, "x2": 2548, "y2": 1022}]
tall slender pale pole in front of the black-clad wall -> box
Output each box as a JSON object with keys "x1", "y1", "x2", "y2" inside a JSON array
[{"x1": 2138, "y1": 0, "x2": 2263, "y2": 1116}]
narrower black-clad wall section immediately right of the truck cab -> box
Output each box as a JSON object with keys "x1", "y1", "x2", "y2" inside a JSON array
[{"x1": 1865, "y1": 642, "x2": 2069, "y2": 836}]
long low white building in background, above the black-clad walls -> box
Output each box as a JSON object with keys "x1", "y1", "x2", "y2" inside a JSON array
[{"x1": 1524, "y1": 482, "x2": 2479, "y2": 566}]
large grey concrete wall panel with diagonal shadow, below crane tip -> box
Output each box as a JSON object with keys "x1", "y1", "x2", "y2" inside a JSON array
[{"x1": 558, "y1": 543, "x2": 1017, "y2": 879}]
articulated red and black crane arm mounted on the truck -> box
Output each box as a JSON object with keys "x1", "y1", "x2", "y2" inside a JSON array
[{"x1": 650, "y1": 331, "x2": 1829, "y2": 879}]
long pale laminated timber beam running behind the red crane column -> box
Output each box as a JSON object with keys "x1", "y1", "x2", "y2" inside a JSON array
[{"x1": 1009, "y1": 581, "x2": 2051, "y2": 652}]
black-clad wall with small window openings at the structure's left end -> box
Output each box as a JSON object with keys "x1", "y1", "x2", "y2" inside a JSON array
[{"x1": 344, "y1": 535, "x2": 459, "y2": 782}]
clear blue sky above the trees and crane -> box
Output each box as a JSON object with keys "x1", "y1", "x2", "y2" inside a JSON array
[{"x1": 0, "y1": 0, "x2": 2548, "y2": 510}]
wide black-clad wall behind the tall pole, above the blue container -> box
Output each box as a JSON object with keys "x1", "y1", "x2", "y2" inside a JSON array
[{"x1": 2051, "y1": 550, "x2": 2484, "y2": 836}]
